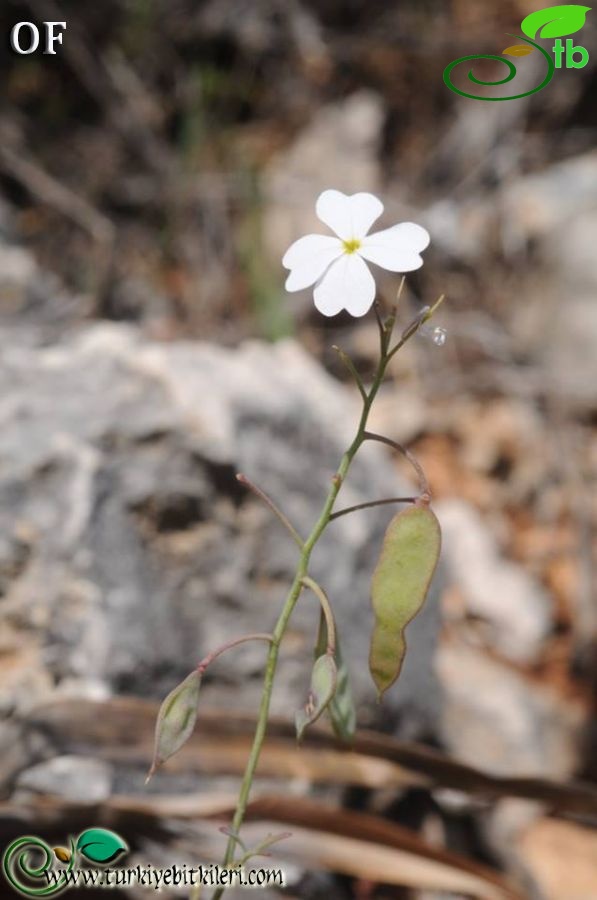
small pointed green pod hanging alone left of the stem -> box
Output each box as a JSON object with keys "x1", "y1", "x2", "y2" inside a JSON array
[{"x1": 146, "y1": 669, "x2": 201, "y2": 783}]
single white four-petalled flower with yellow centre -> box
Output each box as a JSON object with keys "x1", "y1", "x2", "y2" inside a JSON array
[{"x1": 282, "y1": 191, "x2": 429, "y2": 316}]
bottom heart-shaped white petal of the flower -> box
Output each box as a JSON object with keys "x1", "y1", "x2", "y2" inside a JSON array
[{"x1": 313, "y1": 253, "x2": 375, "y2": 316}]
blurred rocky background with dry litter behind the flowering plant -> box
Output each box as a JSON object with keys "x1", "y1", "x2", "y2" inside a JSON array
[{"x1": 0, "y1": 0, "x2": 597, "y2": 900}]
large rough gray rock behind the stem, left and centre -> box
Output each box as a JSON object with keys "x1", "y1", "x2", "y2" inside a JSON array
[{"x1": 0, "y1": 325, "x2": 439, "y2": 736}]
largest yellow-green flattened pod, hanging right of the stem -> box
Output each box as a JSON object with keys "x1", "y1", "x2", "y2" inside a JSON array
[{"x1": 369, "y1": 506, "x2": 441, "y2": 698}]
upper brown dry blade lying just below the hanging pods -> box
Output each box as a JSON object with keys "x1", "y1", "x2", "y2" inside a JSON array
[{"x1": 27, "y1": 697, "x2": 597, "y2": 817}]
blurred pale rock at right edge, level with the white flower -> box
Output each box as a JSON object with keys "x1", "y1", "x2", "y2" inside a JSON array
[{"x1": 420, "y1": 152, "x2": 597, "y2": 413}]
